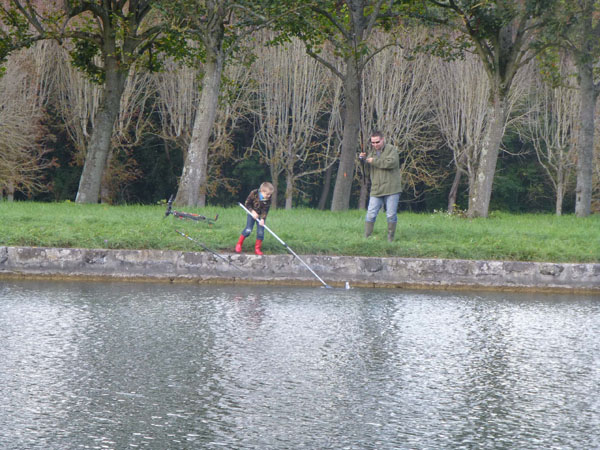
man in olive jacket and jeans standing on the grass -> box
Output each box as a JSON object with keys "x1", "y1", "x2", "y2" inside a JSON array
[{"x1": 359, "y1": 131, "x2": 402, "y2": 242}]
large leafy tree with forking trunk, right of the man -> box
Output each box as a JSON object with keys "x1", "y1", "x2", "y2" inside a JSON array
[{"x1": 428, "y1": 0, "x2": 556, "y2": 217}]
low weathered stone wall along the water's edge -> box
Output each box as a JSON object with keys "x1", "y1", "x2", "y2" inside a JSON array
[{"x1": 0, "y1": 247, "x2": 600, "y2": 294}]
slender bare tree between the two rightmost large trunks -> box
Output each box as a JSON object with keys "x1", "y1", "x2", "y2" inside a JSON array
[{"x1": 517, "y1": 60, "x2": 580, "y2": 216}]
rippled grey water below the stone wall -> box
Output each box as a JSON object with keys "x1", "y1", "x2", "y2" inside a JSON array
[{"x1": 0, "y1": 281, "x2": 600, "y2": 450}]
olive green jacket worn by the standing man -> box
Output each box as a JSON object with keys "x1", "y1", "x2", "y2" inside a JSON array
[{"x1": 367, "y1": 144, "x2": 402, "y2": 197}]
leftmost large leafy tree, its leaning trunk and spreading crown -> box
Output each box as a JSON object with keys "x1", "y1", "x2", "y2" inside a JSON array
[{"x1": 7, "y1": 0, "x2": 172, "y2": 203}]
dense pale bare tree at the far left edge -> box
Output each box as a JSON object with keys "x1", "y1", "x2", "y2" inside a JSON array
[{"x1": 0, "y1": 43, "x2": 54, "y2": 200}]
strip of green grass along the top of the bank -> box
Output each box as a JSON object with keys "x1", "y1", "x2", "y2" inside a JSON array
[{"x1": 0, "y1": 202, "x2": 600, "y2": 262}]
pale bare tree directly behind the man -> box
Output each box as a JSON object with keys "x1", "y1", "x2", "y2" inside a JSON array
[{"x1": 361, "y1": 29, "x2": 439, "y2": 207}]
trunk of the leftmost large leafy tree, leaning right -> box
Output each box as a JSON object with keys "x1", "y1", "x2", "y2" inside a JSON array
[{"x1": 75, "y1": 57, "x2": 128, "y2": 203}]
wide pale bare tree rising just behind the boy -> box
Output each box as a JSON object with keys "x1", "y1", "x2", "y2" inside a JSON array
[{"x1": 253, "y1": 39, "x2": 338, "y2": 209}]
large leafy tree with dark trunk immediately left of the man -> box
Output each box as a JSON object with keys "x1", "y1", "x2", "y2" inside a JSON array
[{"x1": 275, "y1": 0, "x2": 410, "y2": 211}]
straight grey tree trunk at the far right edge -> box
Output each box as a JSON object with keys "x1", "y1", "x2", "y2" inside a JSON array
[{"x1": 575, "y1": 61, "x2": 598, "y2": 217}]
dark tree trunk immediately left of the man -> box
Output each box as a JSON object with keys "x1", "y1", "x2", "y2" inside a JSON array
[{"x1": 331, "y1": 57, "x2": 358, "y2": 211}]
